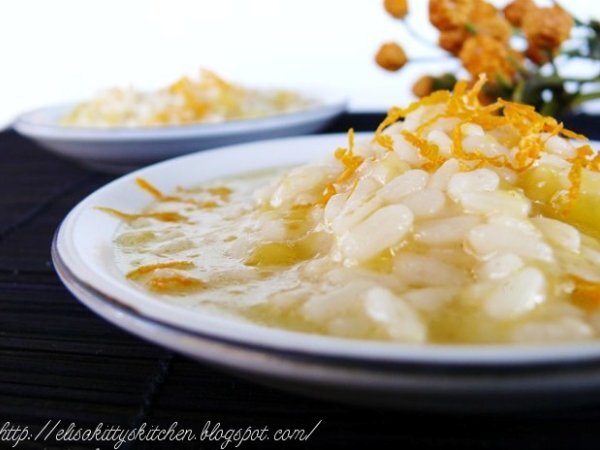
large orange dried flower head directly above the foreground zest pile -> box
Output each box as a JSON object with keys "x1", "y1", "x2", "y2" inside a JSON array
[{"x1": 459, "y1": 35, "x2": 516, "y2": 84}]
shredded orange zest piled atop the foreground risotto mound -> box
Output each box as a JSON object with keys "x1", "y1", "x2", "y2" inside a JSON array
[{"x1": 366, "y1": 75, "x2": 600, "y2": 215}]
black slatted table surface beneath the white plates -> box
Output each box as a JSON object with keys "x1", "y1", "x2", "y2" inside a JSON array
[{"x1": 0, "y1": 115, "x2": 600, "y2": 449}]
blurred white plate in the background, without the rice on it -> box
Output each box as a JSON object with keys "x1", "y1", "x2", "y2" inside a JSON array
[{"x1": 13, "y1": 93, "x2": 346, "y2": 173}]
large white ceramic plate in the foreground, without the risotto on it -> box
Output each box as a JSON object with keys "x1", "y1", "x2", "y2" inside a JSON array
[{"x1": 53, "y1": 135, "x2": 600, "y2": 411}]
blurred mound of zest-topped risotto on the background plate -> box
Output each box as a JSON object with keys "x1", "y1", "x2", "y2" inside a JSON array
[{"x1": 61, "y1": 70, "x2": 316, "y2": 127}]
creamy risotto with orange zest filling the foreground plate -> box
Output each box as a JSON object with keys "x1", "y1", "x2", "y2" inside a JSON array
[{"x1": 104, "y1": 79, "x2": 600, "y2": 344}]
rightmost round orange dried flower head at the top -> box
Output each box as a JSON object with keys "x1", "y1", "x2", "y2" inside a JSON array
[{"x1": 522, "y1": 5, "x2": 573, "y2": 50}]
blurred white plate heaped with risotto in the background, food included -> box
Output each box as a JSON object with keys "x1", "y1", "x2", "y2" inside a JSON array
[{"x1": 14, "y1": 74, "x2": 346, "y2": 173}]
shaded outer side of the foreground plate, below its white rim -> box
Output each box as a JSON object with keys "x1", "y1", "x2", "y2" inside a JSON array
[{"x1": 52, "y1": 239, "x2": 600, "y2": 414}]
